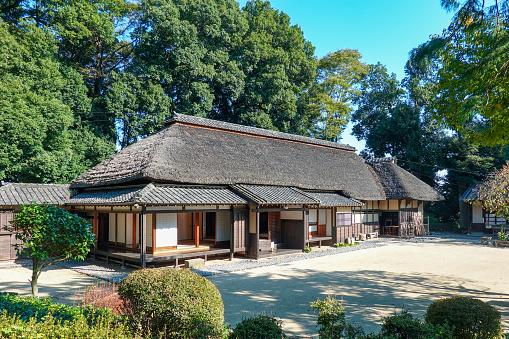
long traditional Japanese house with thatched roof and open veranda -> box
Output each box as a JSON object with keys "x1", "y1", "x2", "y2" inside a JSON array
[{"x1": 62, "y1": 114, "x2": 441, "y2": 265}]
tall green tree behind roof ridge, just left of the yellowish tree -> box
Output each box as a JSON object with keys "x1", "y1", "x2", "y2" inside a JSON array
[{"x1": 233, "y1": 0, "x2": 316, "y2": 132}]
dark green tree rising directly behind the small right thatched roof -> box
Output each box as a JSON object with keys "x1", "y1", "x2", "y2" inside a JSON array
[{"x1": 352, "y1": 64, "x2": 443, "y2": 185}]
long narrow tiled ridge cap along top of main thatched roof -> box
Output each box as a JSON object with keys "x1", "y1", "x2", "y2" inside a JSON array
[{"x1": 163, "y1": 112, "x2": 356, "y2": 151}]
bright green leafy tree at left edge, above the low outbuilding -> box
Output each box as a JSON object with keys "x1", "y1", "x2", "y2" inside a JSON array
[{"x1": 0, "y1": 21, "x2": 112, "y2": 183}]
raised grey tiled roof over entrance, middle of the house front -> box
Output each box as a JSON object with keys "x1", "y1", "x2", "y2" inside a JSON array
[{"x1": 232, "y1": 184, "x2": 319, "y2": 205}]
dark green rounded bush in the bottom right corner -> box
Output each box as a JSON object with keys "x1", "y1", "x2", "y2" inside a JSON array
[{"x1": 426, "y1": 296, "x2": 502, "y2": 339}]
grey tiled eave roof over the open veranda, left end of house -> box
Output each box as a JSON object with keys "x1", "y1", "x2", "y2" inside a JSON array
[{"x1": 67, "y1": 184, "x2": 247, "y2": 205}]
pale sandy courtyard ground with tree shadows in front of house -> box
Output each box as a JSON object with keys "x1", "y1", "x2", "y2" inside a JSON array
[{"x1": 0, "y1": 236, "x2": 509, "y2": 337}]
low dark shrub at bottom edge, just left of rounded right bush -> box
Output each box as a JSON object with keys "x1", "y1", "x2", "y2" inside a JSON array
[{"x1": 380, "y1": 311, "x2": 452, "y2": 339}]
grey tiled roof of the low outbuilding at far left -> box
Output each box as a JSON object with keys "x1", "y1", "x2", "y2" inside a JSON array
[{"x1": 0, "y1": 183, "x2": 69, "y2": 206}]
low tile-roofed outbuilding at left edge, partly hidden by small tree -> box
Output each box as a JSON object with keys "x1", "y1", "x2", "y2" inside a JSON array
[{"x1": 0, "y1": 181, "x2": 69, "y2": 261}]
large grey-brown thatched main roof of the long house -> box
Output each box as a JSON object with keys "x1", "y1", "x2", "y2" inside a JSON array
[{"x1": 71, "y1": 114, "x2": 436, "y2": 200}]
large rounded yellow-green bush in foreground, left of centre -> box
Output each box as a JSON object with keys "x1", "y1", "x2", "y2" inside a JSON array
[{"x1": 118, "y1": 267, "x2": 224, "y2": 338}]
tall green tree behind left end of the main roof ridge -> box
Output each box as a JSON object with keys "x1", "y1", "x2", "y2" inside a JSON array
[{"x1": 132, "y1": 0, "x2": 247, "y2": 120}]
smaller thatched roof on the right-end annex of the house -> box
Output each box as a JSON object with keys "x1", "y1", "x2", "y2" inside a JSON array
[{"x1": 367, "y1": 158, "x2": 444, "y2": 201}]
